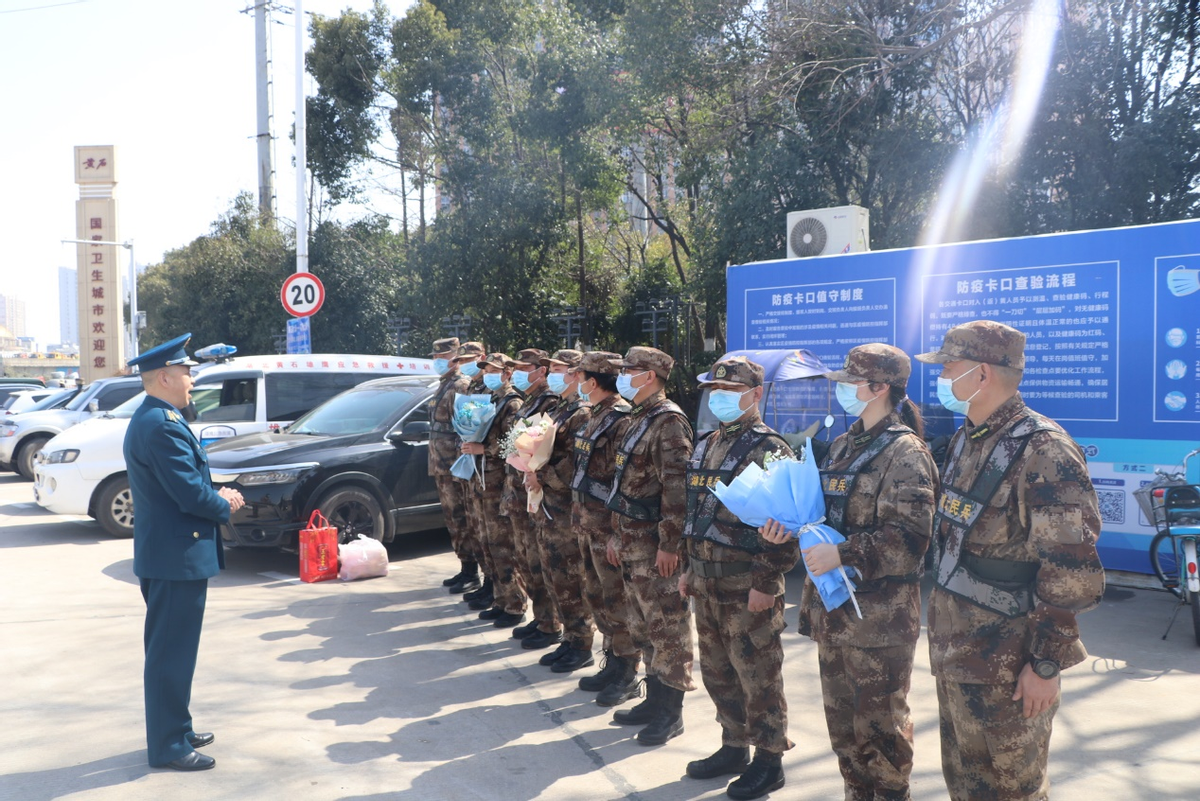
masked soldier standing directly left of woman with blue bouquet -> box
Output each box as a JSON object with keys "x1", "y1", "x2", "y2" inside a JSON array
[{"x1": 679, "y1": 356, "x2": 800, "y2": 799}]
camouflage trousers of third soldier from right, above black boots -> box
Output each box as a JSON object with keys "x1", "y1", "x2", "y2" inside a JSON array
[{"x1": 692, "y1": 594, "x2": 794, "y2": 754}]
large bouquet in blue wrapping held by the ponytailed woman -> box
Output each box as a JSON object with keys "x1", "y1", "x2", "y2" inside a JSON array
[{"x1": 713, "y1": 440, "x2": 863, "y2": 618}]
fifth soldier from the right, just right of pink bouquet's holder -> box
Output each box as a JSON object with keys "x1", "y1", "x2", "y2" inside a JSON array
[{"x1": 571, "y1": 350, "x2": 642, "y2": 706}]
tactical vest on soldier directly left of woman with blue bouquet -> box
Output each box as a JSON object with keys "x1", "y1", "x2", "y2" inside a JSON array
[{"x1": 683, "y1": 422, "x2": 784, "y2": 554}]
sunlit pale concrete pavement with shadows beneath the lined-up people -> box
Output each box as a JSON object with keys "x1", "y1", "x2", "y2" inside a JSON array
[{"x1": 0, "y1": 474, "x2": 1200, "y2": 801}]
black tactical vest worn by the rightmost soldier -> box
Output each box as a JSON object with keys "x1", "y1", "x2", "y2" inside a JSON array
[{"x1": 934, "y1": 414, "x2": 1055, "y2": 619}]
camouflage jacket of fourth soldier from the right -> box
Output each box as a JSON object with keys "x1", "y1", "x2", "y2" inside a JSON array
[{"x1": 609, "y1": 392, "x2": 692, "y2": 559}]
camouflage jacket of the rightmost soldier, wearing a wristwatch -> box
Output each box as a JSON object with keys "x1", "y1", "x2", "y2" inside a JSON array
[{"x1": 929, "y1": 393, "x2": 1104, "y2": 683}]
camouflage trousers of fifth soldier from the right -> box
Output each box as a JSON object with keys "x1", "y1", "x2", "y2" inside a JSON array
[{"x1": 571, "y1": 501, "x2": 642, "y2": 668}]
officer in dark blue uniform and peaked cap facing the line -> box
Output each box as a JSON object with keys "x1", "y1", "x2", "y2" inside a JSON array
[{"x1": 125, "y1": 333, "x2": 244, "y2": 771}]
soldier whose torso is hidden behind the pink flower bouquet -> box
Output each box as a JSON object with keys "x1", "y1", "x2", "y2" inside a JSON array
[{"x1": 500, "y1": 348, "x2": 563, "y2": 650}]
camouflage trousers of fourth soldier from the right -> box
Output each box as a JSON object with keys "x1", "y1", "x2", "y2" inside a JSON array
[{"x1": 622, "y1": 549, "x2": 696, "y2": 691}]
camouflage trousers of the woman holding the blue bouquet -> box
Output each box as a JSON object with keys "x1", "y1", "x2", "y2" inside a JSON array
[{"x1": 817, "y1": 643, "x2": 917, "y2": 801}]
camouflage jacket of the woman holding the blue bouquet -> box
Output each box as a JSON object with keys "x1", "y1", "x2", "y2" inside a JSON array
[{"x1": 799, "y1": 411, "x2": 937, "y2": 648}]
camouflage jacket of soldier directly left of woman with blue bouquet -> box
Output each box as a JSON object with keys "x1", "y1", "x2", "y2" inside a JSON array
[{"x1": 684, "y1": 411, "x2": 800, "y2": 602}]
